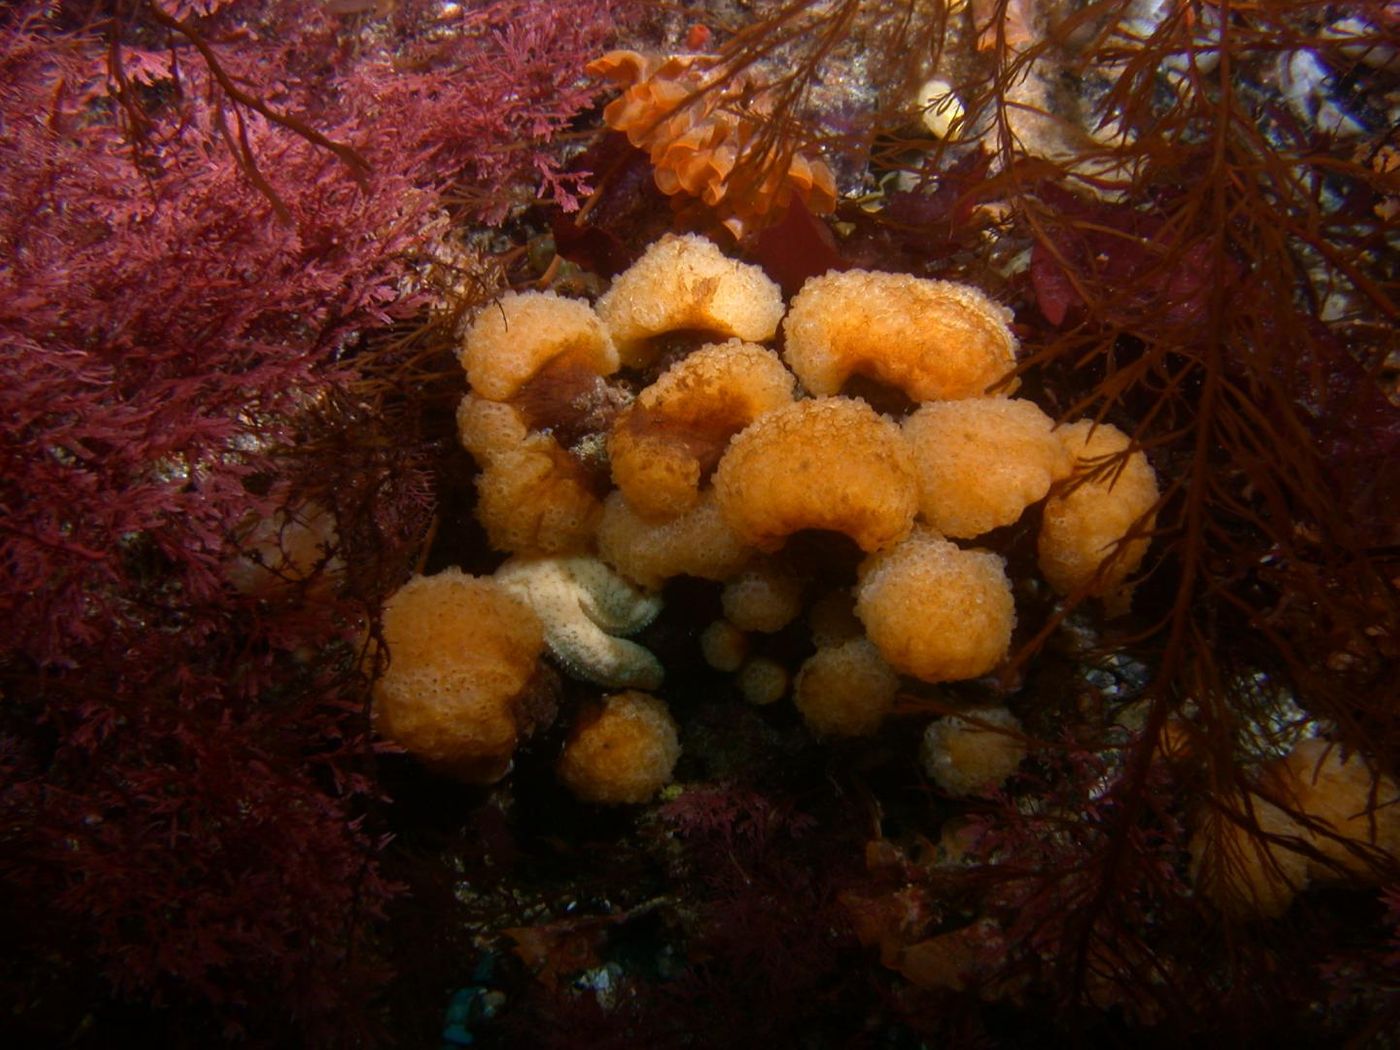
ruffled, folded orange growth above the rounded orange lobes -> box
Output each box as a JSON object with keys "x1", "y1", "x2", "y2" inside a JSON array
[{"x1": 585, "y1": 50, "x2": 836, "y2": 238}]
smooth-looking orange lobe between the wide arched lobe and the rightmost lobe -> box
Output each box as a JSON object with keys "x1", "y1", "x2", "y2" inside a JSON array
[{"x1": 903, "y1": 398, "x2": 1074, "y2": 539}]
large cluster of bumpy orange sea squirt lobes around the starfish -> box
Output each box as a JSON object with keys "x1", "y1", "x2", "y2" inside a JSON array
[{"x1": 377, "y1": 235, "x2": 1156, "y2": 801}]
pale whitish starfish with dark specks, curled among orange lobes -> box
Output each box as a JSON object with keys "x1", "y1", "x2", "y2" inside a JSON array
[{"x1": 496, "y1": 554, "x2": 664, "y2": 689}]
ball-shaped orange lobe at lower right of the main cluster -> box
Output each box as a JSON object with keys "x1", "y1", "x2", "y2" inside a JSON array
[{"x1": 855, "y1": 529, "x2": 1016, "y2": 682}]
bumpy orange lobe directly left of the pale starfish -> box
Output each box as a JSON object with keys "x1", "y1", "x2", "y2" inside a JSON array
[{"x1": 374, "y1": 568, "x2": 545, "y2": 784}]
